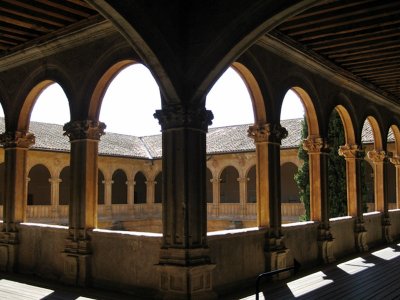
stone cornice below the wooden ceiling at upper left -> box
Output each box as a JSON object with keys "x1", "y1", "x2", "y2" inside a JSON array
[{"x1": 0, "y1": 18, "x2": 117, "y2": 72}]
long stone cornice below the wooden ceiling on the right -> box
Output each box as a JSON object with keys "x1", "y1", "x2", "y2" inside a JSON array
[{"x1": 257, "y1": 31, "x2": 400, "y2": 114}]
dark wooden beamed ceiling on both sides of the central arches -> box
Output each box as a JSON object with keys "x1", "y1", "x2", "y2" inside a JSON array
[{"x1": 0, "y1": 0, "x2": 400, "y2": 103}]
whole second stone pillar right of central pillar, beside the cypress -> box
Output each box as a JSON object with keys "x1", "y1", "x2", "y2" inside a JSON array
[{"x1": 303, "y1": 136, "x2": 335, "y2": 263}]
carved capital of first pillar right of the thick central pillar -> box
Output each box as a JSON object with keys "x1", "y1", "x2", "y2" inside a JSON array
[{"x1": 247, "y1": 123, "x2": 288, "y2": 144}]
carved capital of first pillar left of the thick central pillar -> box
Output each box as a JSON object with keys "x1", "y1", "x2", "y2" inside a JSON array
[{"x1": 63, "y1": 120, "x2": 106, "y2": 141}]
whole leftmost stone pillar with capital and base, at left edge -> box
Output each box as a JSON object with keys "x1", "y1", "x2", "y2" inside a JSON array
[{"x1": 0, "y1": 131, "x2": 35, "y2": 272}]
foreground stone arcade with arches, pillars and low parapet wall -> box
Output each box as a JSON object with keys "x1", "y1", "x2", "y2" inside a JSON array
[{"x1": 0, "y1": 0, "x2": 400, "y2": 299}]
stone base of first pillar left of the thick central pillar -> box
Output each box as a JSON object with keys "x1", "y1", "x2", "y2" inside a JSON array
[{"x1": 62, "y1": 239, "x2": 91, "y2": 287}]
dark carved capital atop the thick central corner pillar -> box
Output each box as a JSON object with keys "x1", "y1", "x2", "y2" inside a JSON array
[{"x1": 153, "y1": 105, "x2": 214, "y2": 132}]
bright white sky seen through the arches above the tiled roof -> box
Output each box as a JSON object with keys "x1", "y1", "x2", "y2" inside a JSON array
[{"x1": 18, "y1": 64, "x2": 304, "y2": 136}]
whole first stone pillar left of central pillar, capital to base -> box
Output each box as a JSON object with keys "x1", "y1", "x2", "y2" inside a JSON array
[{"x1": 63, "y1": 120, "x2": 105, "y2": 286}]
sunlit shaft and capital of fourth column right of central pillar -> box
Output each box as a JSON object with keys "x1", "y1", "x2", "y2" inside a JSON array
[{"x1": 368, "y1": 150, "x2": 386, "y2": 212}]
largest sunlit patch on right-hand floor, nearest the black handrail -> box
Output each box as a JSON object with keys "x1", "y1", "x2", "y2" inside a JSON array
[{"x1": 287, "y1": 271, "x2": 333, "y2": 297}]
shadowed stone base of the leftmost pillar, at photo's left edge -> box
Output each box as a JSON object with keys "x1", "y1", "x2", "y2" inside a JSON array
[{"x1": 0, "y1": 232, "x2": 18, "y2": 272}]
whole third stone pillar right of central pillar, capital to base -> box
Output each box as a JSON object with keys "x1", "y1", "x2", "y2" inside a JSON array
[{"x1": 339, "y1": 144, "x2": 368, "y2": 252}]
